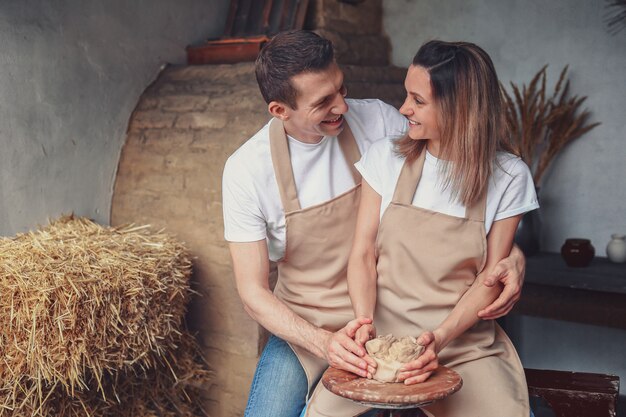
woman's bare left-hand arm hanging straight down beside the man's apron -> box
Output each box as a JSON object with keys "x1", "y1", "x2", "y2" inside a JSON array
[{"x1": 348, "y1": 180, "x2": 381, "y2": 346}]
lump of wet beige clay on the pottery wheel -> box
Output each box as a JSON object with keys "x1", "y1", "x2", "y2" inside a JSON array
[{"x1": 365, "y1": 334, "x2": 424, "y2": 382}]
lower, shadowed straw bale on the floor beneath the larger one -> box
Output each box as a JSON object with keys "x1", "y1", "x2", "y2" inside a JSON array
[{"x1": 0, "y1": 332, "x2": 210, "y2": 417}]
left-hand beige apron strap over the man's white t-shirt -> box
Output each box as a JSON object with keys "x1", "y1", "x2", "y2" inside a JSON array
[{"x1": 270, "y1": 119, "x2": 300, "y2": 213}]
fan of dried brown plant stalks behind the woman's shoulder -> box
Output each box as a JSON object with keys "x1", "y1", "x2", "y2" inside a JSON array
[{"x1": 501, "y1": 65, "x2": 600, "y2": 187}]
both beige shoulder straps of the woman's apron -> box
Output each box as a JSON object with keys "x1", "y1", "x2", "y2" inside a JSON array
[{"x1": 391, "y1": 148, "x2": 487, "y2": 222}]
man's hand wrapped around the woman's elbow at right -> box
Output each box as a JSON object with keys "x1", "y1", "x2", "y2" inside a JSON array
[{"x1": 478, "y1": 246, "x2": 526, "y2": 320}]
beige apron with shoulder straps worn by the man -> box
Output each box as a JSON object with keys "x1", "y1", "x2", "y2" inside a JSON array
[{"x1": 270, "y1": 119, "x2": 361, "y2": 391}]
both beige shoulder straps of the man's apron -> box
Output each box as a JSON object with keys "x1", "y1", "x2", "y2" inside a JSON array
[{"x1": 270, "y1": 118, "x2": 361, "y2": 213}]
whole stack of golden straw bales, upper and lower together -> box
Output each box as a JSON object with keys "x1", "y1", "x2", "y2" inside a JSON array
[{"x1": 0, "y1": 216, "x2": 209, "y2": 417}]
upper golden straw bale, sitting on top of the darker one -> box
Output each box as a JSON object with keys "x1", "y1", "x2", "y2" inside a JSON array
[{"x1": 0, "y1": 216, "x2": 191, "y2": 395}]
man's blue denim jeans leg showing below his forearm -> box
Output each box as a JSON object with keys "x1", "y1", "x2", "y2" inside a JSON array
[{"x1": 244, "y1": 335, "x2": 308, "y2": 417}]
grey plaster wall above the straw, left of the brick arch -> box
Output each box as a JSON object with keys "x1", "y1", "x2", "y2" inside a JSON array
[{"x1": 0, "y1": 0, "x2": 229, "y2": 235}]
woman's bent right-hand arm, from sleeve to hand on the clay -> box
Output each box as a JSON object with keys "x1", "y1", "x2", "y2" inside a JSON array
[{"x1": 399, "y1": 215, "x2": 522, "y2": 384}]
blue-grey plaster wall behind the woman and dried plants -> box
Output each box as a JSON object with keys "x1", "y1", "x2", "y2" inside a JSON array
[{"x1": 383, "y1": 0, "x2": 626, "y2": 256}]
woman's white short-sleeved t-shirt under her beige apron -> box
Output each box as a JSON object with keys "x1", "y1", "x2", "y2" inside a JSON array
[{"x1": 356, "y1": 138, "x2": 539, "y2": 233}]
